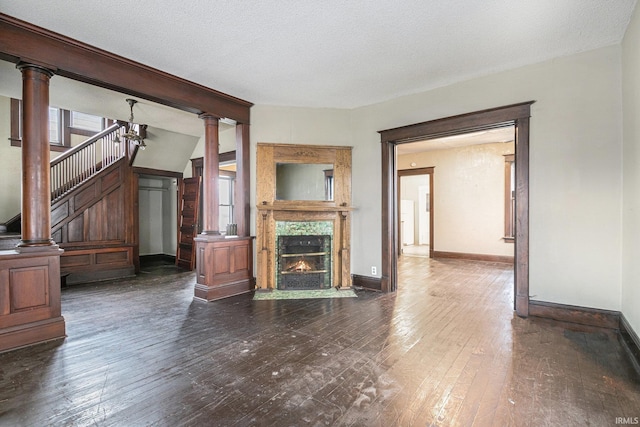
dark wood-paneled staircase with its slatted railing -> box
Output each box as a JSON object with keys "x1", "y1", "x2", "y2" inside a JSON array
[{"x1": 0, "y1": 122, "x2": 138, "y2": 284}]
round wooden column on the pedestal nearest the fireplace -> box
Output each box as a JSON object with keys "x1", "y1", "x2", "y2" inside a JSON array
[{"x1": 199, "y1": 113, "x2": 220, "y2": 235}]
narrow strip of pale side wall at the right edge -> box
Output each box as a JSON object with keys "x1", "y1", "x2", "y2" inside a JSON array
[{"x1": 621, "y1": 6, "x2": 640, "y2": 333}]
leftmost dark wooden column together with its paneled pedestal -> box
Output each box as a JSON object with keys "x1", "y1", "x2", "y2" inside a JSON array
[{"x1": 0, "y1": 63, "x2": 65, "y2": 351}]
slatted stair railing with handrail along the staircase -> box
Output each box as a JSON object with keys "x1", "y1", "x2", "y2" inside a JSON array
[{"x1": 50, "y1": 122, "x2": 126, "y2": 202}]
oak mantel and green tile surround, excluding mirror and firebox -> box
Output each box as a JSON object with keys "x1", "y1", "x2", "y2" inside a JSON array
[{"x1": 256, "y1": 143, "x2": 352, "y2": 290}]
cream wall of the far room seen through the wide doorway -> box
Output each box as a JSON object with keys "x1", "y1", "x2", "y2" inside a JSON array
[{"x1": 398, "y1": 143, "x2": 514, "y2": 256}]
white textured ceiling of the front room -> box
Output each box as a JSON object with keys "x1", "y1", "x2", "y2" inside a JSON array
[{"x1": 0, "y1": 0, "x2": 636, "y2": 108}]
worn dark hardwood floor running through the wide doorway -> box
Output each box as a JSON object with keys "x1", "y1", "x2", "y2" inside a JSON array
[{"x1": 0, "y1": 257, "x2": 640, "y2": 426}]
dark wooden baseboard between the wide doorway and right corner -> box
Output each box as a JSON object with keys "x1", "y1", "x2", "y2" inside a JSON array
[{"x1": 529, "y1": 300, "x2": 620, "y2": 330}]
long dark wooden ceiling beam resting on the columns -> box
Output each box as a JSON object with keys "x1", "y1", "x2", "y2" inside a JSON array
[{"x1": 0, "y1": 14, "x2": 253, "y2": 123}]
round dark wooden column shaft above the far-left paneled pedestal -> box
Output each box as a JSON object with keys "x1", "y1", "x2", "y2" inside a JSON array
[{"x1": 18, "y1": 63, "x2": 56, "y2": 248}]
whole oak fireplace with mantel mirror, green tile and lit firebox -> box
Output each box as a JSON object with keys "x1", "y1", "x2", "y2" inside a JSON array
[{"x1": 256, "y1": 142, "x2": 354, "y2": 290}]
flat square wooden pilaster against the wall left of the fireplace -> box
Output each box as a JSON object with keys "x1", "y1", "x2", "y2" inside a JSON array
[{"x1": 234, "y1": 123, "x2": 251, "y2": 236}]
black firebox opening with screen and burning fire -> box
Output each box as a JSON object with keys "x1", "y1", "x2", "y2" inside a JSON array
[{"x1": 277, "y1": 235, "x2": 331, "y2": 290}]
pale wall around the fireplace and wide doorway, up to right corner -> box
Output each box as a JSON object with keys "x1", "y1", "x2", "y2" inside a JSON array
[{"x1": 251, "y1": 46, "x2": 622, "y2": 310}]
